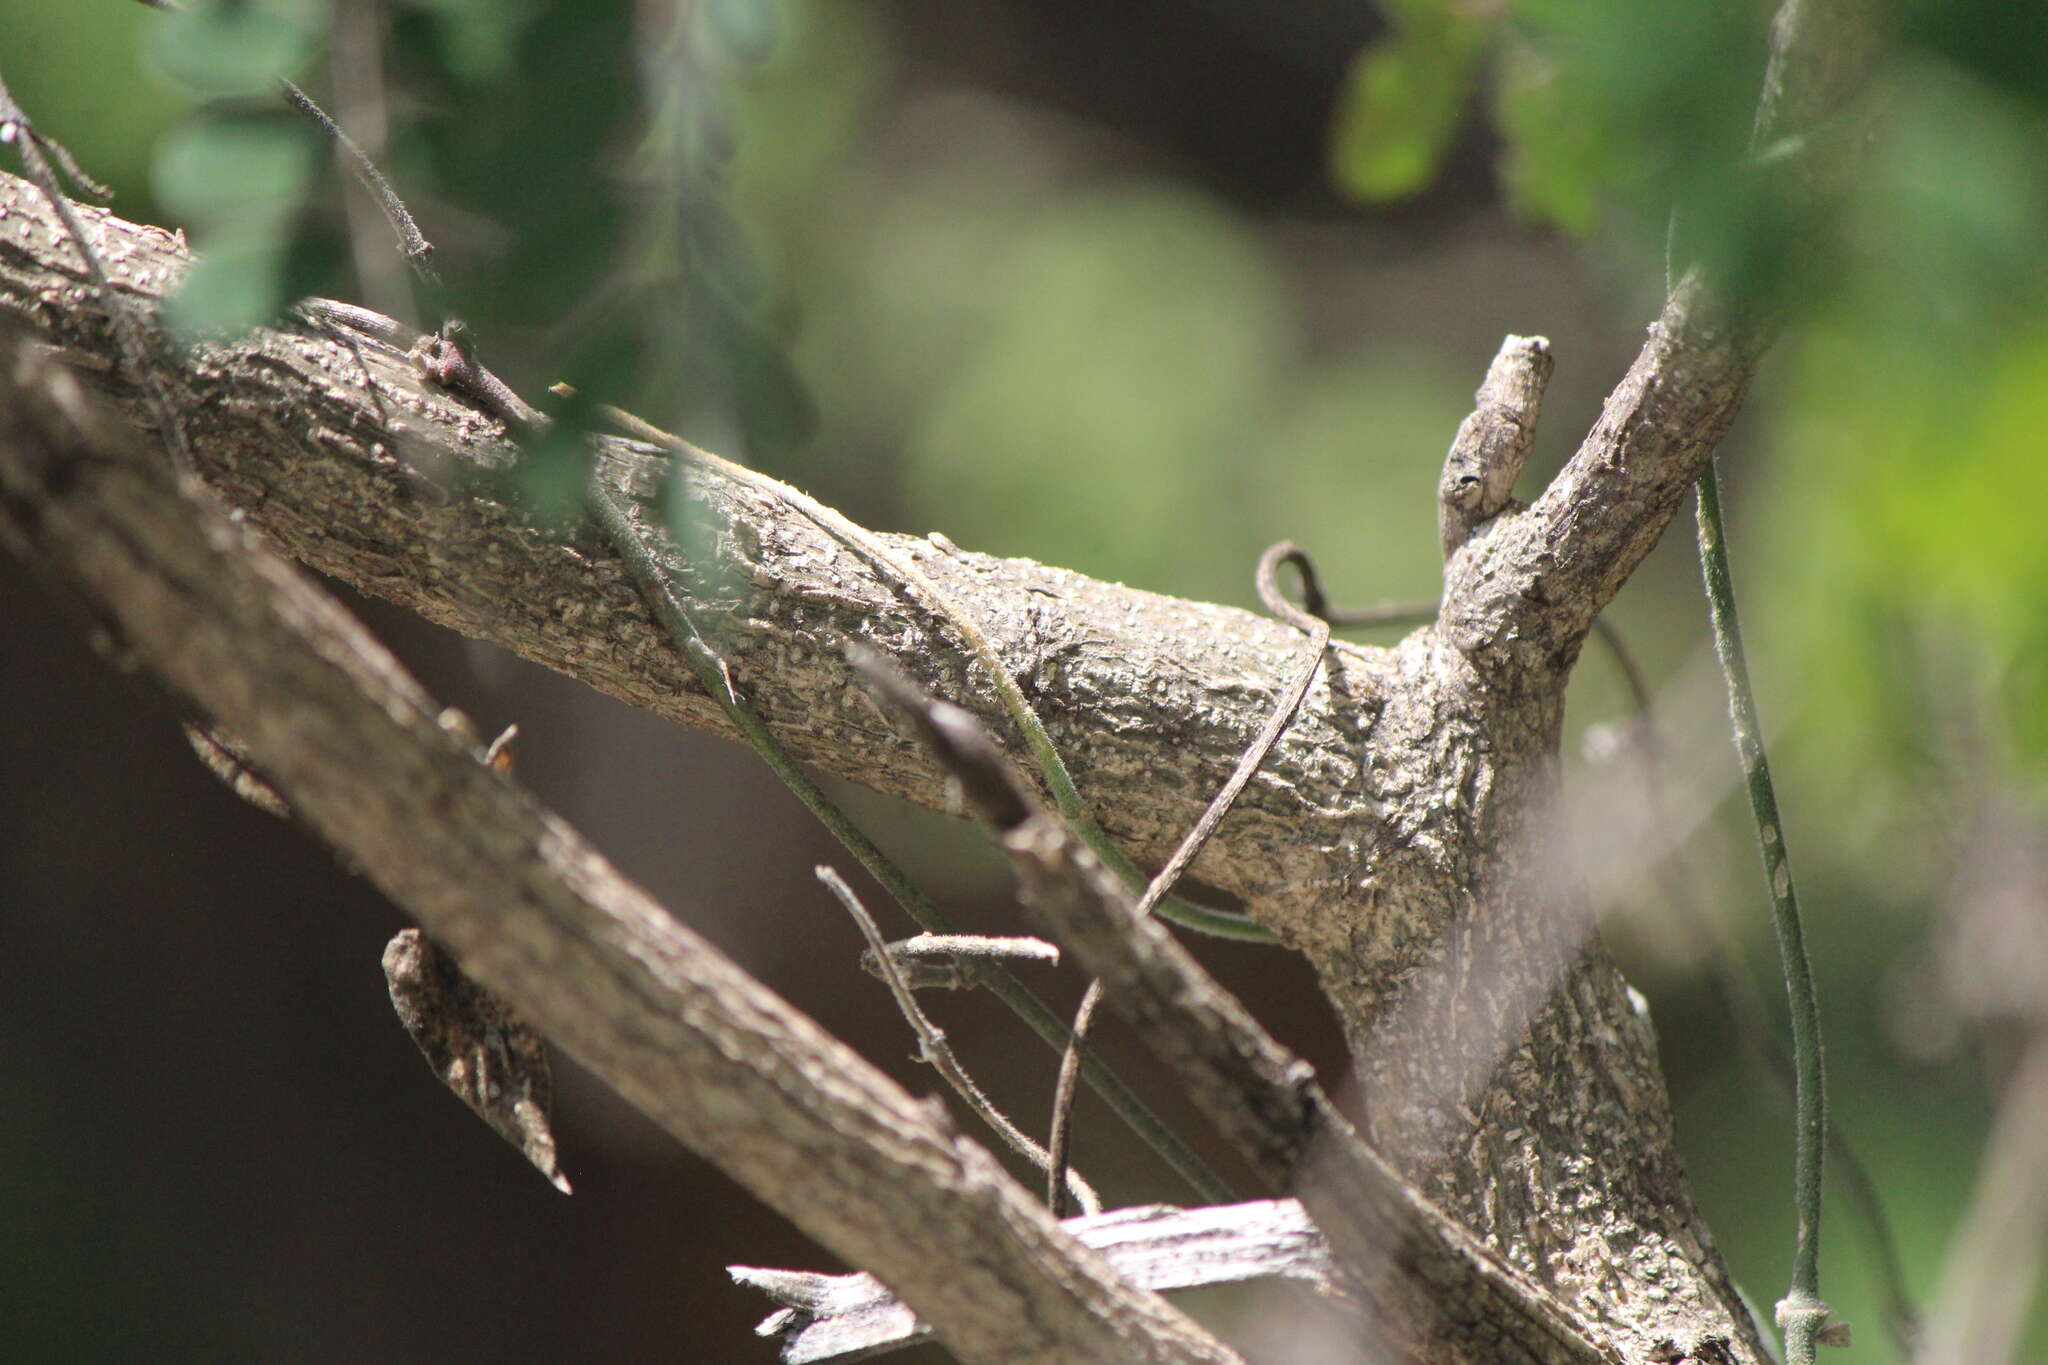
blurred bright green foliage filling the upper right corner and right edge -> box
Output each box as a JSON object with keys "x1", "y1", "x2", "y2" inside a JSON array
[{"x1": 1331, "y1": 0, "x2": 2048, "y2": 782}]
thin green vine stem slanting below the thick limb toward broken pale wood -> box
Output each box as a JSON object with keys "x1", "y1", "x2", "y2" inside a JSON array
[{"x1": 590, "y1": 483, "x2": 1233, "y2": 1203}]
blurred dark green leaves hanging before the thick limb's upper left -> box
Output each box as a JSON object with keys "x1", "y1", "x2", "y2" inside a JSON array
[{"x1": 125, "y1": 0, "x2": 813, "y2": 466}]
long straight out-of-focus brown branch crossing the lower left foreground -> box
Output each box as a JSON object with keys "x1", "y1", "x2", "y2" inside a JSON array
[{"x1": 0, "y1": 351, "x2": 1237, "y2": 1365}]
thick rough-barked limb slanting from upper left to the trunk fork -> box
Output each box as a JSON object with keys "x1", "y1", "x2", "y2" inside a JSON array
[{"x1": 0, "y1": 176, "x2": 1378, "y2": 945}]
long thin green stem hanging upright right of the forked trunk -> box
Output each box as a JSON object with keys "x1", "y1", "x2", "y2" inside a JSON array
[{"x1": 1698, "y1": 460, "x2": 1829, "y2": 1365}]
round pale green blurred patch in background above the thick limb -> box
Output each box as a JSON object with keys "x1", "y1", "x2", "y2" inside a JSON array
[{"x1": 905, "y1": 188, "x2": 1280, "y2": 581}]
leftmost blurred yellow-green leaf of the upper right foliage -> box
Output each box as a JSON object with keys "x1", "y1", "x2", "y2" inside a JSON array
[{"x1": 1329, "y1": 14, "x2": 1485, "y2": 203}]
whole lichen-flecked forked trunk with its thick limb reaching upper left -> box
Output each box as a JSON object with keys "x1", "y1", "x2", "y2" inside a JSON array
[{"x1": 0, "y1": 180, "x2": 1757, "y2": 1361}]
